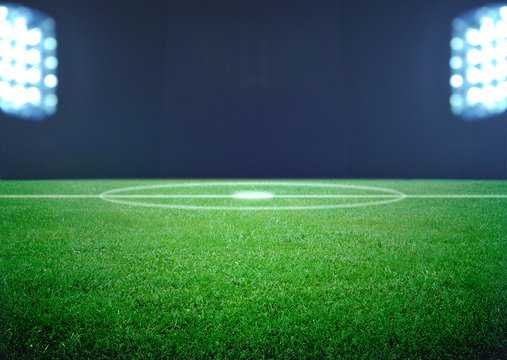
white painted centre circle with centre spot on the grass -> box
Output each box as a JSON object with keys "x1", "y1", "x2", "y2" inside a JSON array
[{"x1": 99, "y1": 181, "x2": 406, "y2": 211}]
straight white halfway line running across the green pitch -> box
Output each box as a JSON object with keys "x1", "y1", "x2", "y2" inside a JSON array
[{"x1": 0, "y1": 194, "x2": 507, "y2": 199}]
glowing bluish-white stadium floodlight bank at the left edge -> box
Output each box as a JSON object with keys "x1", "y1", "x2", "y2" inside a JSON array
[{"x1": 0, "y1": 3, "x2": 58, "y2": 120}]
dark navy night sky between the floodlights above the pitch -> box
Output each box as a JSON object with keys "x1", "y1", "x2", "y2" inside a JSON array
[{"x1": 0, "y1": 0, "x2": 507, "y2": 179}]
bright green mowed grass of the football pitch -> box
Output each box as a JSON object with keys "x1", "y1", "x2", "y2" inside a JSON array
[{"x1": 0, "y1": 180, "x2": 507, "y2": 359}]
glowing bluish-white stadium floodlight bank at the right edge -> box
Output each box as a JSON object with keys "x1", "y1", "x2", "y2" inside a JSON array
[{"x1": 449, "y1": 3, "x2": 507, "y2": 120}]
